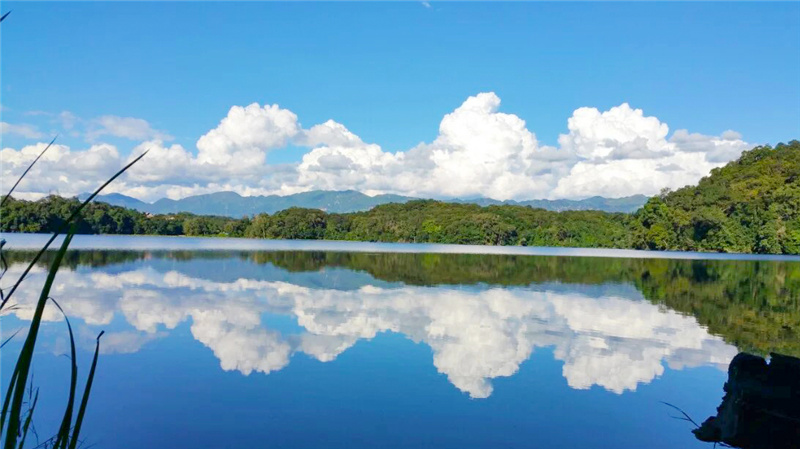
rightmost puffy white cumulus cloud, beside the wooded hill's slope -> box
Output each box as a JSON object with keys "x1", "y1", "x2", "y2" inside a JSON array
[{"x1": 552, "y1": 104, "x2": 751, "y2": 198}]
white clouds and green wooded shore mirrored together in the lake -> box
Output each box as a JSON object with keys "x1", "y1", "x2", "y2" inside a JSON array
[{"x1": 9, "y1": 251, "x2": 800, "y2": 398}]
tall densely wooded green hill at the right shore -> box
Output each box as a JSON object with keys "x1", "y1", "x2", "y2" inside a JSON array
[{"x1": 635, "y1": 140, "x2": 800, "y2": 254}]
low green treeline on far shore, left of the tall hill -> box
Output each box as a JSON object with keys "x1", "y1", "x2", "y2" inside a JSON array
[{"x1": 0, "y1": 192, "x2": 635, "y2": 248}]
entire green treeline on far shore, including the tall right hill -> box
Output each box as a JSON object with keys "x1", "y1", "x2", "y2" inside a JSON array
[{"x1": 0, "y1": 141, "x2": 800, "y2": 254}]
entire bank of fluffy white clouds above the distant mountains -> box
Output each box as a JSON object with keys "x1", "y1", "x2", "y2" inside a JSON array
[{"x1": 0, "y1": 92, "x2": 752, "y2": 200}]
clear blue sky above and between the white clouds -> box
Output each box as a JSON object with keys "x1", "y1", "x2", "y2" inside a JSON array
[{"x1": 0, "y1": 2, "x2": 800, "y2": 201}]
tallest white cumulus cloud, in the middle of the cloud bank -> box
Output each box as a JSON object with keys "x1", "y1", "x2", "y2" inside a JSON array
[{"x1": 298, "y1": 93, "x2": 570, "y2": 199}]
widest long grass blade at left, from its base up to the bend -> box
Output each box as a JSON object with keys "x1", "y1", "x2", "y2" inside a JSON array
[{"x1": 0, "y1": 226, "x2": 75, "y2": 449}]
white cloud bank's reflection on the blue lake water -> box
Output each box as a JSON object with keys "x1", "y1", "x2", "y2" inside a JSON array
[{"x1": 4, "y1": 265, "x2": 737, "y2": 398}]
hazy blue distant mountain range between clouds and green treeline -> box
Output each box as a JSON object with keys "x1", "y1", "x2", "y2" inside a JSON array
[{"x1": 79, "y1": 190, "x2": 647, "y2": 217}]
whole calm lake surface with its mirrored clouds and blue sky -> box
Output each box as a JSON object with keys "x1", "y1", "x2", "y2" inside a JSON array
[{"x1": 1, "y1": 235, "x2": 800, "y2": 449}]
